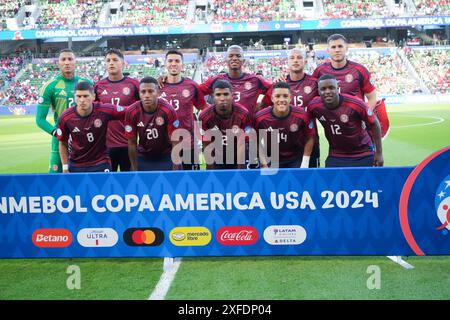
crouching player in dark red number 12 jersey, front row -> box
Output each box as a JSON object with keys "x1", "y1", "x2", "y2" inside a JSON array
[{"x1": 308, "y1": 74, "x2": 384, "y2": 167}]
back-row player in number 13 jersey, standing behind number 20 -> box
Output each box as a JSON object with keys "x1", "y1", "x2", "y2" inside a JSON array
[{"x1": 160, "y1": 50, "x2": 206, "y2": 170}]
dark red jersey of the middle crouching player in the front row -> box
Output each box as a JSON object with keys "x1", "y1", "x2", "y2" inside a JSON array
[{"x1": 199, "y1": 104, "x2": 251, "y2": 164}]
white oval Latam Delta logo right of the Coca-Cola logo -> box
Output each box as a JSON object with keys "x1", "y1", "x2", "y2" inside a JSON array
[{"x1": 264, "y1": 225, "x2": 306, "y2": 246}]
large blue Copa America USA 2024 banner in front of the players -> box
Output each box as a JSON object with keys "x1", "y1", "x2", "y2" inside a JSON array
[{"x1": 0, "y1": 147, "x2": 450, "y2": 258}]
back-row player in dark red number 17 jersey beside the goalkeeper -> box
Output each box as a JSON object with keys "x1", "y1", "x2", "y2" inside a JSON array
[{"x1": 94, "y1": 49, "x2": 139, "y2": 171}]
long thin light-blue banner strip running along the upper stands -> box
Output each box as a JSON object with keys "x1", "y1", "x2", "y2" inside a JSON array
[{"x1": 0, "y1": 16, "x2": 450, "y2": 40}]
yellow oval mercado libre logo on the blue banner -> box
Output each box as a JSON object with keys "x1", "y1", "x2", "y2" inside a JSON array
[{"x1": 169, "y1": 227, "x2": 211, "y2": 246}]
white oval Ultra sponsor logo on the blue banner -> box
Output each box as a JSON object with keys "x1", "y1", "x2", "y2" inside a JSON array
[{"x1": 77, "y1": 228, "x2": 119, "y2": 248}]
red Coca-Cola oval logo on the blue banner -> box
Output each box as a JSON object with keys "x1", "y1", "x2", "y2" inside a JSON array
[{"x1": 216, "y1": 226, "x2": 259, "y2": 246}]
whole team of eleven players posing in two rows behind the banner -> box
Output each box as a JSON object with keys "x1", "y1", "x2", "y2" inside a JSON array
[{"x1": 36, "y1": 34, "x2": 383, "y2": 173}]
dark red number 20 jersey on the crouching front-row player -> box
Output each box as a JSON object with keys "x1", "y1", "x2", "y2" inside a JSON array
[{"x1": 125, "y1": 98, "x2": 179, "y2": 158}]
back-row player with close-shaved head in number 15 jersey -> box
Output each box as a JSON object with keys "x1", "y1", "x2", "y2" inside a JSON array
[{"x1": 260, "y1": 48, "x2": 320, "y2": 168}]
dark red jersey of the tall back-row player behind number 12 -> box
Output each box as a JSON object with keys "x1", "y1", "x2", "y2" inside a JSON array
[{"x1": 313, "y1": 60, "x2": 375, "y2": 101}]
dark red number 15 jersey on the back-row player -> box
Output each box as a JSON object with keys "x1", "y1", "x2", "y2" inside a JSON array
[{"x1": 262, "y1": 73, "x2": 319, "y2": 108}]
